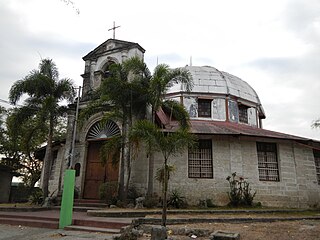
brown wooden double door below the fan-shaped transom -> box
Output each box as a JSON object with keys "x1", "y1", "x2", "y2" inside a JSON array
[{"x1": 83, "y1": 141, "x2": 119, "y2": 199}]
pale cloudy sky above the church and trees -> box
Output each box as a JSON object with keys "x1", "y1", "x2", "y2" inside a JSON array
[{"x1": 0, "y1": 0, "x2": 320, "y2": 140}]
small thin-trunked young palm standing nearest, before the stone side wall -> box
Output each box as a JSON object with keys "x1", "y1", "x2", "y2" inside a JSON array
[{"x1": 131, "y1": 101, "x2": 194, "y2": 226}]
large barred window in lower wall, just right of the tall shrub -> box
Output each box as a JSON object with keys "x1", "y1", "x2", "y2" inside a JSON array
[{"x1": 257, "y1": 142, "x2": 280, "y2": 182}]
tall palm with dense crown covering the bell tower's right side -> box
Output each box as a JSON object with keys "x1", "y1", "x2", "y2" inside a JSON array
[{"x1": 80, "y1": 57, "x2": 150, "y2": 200}]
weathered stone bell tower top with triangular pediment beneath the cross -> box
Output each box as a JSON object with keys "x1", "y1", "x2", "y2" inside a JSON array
[{"x1": 81, "y1": 39, "x2": 145, "y2": 100}]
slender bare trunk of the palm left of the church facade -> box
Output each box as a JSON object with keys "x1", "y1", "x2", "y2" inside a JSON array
[{"x1": 42, "y1": 117, "x2": 53, "y2": 199}]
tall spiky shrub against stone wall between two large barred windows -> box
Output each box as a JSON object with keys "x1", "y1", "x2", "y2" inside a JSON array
[{"x1": 226, "y1": 172, "x2": 256, "y2": 207}]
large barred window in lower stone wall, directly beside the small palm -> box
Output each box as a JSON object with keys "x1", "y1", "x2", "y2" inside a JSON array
[{"x1": 188, "y1": 140, "x2": 213, "y2": 178}]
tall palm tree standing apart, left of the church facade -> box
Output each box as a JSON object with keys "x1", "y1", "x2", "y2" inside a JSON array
[{"x1": 9, "y1": 59, "x2": 75, "y2": 198}]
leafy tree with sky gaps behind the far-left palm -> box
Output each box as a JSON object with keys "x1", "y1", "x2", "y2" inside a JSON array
[{"x1": 0, "y1": 108, "x2": 66, "y2": 187}]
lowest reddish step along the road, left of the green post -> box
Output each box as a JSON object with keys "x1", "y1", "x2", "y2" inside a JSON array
[{"x1": 0, "y1": 217, "x2": 59, "y2": 229}]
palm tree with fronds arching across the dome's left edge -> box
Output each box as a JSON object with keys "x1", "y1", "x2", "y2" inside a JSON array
[{"x1": 147, "y1": 64, "x2": 193, "y2": 196}]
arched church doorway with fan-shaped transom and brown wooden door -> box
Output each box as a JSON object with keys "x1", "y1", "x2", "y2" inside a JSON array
[{"x1": 83, "y1": 121, "x2": 120, "y2": 199}]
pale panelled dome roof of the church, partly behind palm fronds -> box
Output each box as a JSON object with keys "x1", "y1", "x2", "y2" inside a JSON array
[{"x1": 167, "y1": 66, "x2": 261, "y2": 105}]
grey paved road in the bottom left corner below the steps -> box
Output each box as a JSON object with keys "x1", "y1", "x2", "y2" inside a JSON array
[{"x1": 0, "y1": 225, "x2": 113, "y2": 240}]
